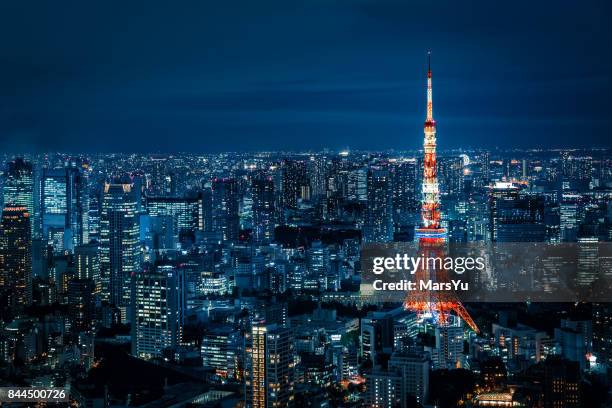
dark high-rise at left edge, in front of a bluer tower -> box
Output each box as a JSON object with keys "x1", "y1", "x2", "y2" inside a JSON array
[{"x1": 0, "y1": 205, "x2": 32, "y2": 307}]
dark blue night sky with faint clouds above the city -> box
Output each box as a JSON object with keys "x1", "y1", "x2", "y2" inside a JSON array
[{"x1": 0, "y1": 0, "x2": 612, "y2": 152}]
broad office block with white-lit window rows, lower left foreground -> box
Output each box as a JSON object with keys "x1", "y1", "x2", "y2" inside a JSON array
[{"x1": 132, "y1": 268, "x2": 184, "y2": 359}]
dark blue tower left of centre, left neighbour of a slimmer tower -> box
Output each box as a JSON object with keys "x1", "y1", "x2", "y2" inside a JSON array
[{"x1": 211, "y1": 178, "x2": 240, "y2": 241}]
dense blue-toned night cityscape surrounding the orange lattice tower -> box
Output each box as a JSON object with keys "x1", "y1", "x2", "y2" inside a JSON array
[{"x1": 0, "y1": 145, "x2": 612, "y2": 407}]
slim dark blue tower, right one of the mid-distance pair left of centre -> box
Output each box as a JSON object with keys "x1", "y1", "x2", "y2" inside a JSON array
[{"x1": 251, "y1": 177, "x2": 275, "y2": 243}]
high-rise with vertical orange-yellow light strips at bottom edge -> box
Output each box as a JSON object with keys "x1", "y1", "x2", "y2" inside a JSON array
[{"x1": 245, "y1": 322, "x2": 295, "y2": 408}]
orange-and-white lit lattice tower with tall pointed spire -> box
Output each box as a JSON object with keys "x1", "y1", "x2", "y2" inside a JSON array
[{"x1": 404, "y1": 54, "x2": 478, "y2": 331}]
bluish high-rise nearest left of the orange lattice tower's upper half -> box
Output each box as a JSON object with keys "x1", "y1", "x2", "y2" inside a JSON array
[{"x1": 363, "y1": 168, "x2": 393, "y2": 242}]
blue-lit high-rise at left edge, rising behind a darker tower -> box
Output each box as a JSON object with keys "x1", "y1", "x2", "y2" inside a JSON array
[{"x1": 3, "y1": 158, "x2": 37, "y2": 237}]
